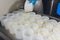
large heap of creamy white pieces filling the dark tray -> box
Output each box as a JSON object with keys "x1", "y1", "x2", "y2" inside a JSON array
[{"x1": 1, "y1": 10, "x2": 60, "y2": 40}]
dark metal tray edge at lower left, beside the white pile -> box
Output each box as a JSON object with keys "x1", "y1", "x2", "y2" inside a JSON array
[{"x1": 0, "y1": 24, "x2": 15, "y2": 40}]
